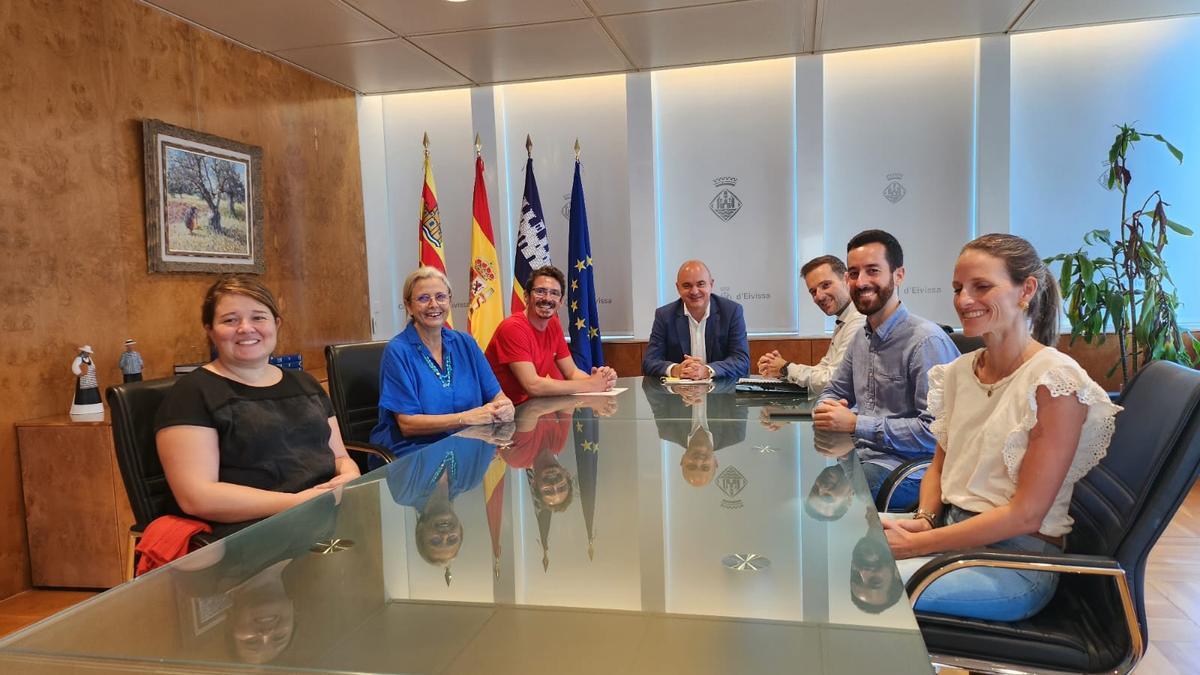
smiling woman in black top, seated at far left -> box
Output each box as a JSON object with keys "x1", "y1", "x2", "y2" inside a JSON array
[{"x1": 155, "y1": 275, "x2": 359, "y2": 524}]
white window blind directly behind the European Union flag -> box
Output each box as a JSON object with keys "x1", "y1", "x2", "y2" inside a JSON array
[{"x1": 496, "y1": 76, "x2": 634, "y2": 338}]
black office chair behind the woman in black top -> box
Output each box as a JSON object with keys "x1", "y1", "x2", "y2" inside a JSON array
[{"x1": 107, "y1": 377, "x2": 208, "y2": 580}]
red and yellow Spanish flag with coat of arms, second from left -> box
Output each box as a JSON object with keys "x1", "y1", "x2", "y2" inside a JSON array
[{"x1": 467, "y1": 147, "x2": 504, "y2": 350}]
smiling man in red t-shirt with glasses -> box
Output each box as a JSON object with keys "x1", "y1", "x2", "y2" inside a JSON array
[{"x1": 484, "y1": 265, "x2": 617, "y2": 405}]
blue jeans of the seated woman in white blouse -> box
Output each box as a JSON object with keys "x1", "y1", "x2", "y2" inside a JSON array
[{"x1": 900, "y1": 506, "x2": 1062, "y2": 621}]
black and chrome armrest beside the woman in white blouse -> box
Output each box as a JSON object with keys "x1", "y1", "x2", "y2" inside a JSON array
[{"x1": 906, "y1": 549, "x2": 1124, "y2": 595}]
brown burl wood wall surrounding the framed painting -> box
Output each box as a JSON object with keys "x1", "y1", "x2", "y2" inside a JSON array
[{"x1": 0, "y1": 0, "x2": 370, "y2": 598}]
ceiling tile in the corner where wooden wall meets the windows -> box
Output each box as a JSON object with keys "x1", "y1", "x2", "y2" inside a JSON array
[{"x1": 276, "y1": 37, "x2": 470, "y2": 94}]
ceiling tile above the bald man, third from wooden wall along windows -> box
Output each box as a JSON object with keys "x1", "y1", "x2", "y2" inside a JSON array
[{"x1": 602, "y1": 0, "x2": 815, "y2": 68}]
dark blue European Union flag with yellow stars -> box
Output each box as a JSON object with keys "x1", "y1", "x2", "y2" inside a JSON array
[{"x1": 566, "y1": 159, "x2": 604, "y2": 372}]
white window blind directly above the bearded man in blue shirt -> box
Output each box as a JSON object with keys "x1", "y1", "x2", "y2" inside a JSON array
[{"x1": 824, "y1": 40, "x2": 978, "y2": 324}]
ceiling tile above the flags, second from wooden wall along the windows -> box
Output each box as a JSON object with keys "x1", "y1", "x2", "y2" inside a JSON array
[{"x1": 412, "y1": 19, "x2": 629, "y2": 84}]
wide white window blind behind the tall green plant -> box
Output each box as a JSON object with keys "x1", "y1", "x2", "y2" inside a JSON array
[{"x1": 1012, "y1": 18, "x2": 1200, "y2": 327}]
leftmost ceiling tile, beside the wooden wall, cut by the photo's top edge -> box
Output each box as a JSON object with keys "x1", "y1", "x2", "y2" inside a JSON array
[{"x1": 148, "y1": 0, "x2": 395, "y2": 52}]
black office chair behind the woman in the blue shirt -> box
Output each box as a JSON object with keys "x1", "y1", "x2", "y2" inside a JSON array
[{"x1": 325, "y1": 340, "x2": 392, "y2": 473}]
